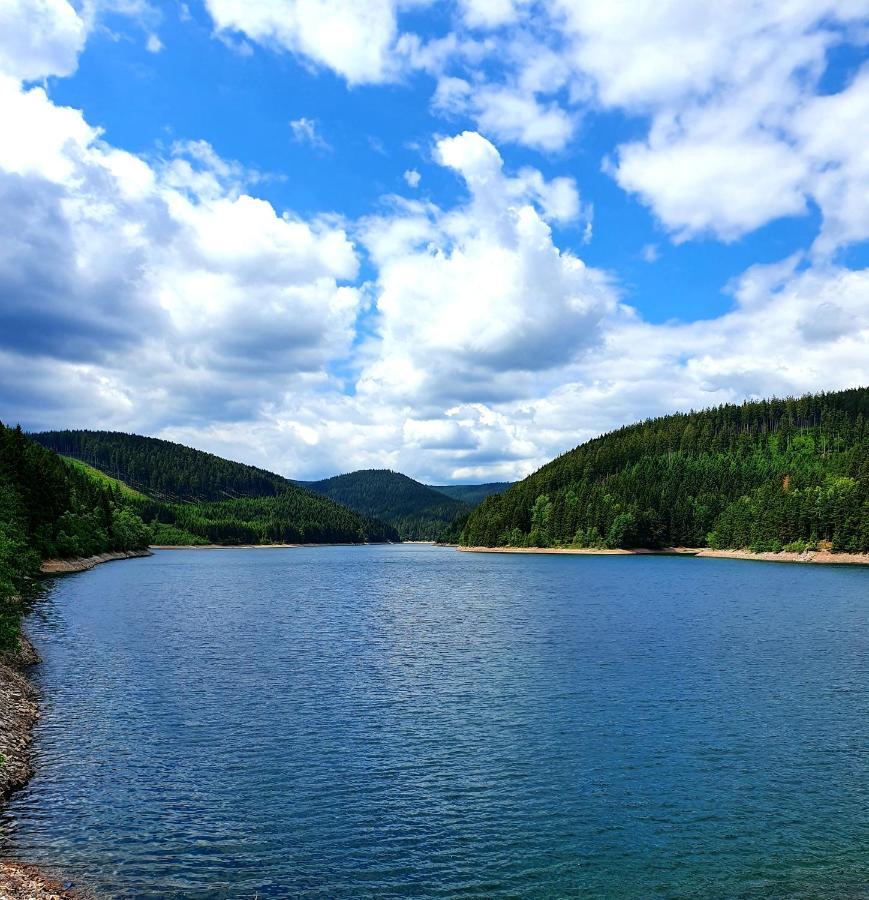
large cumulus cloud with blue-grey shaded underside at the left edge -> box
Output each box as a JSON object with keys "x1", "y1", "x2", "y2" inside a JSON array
[{"x1": 0, "y1": 79, "x2": 360, "y2": 426}]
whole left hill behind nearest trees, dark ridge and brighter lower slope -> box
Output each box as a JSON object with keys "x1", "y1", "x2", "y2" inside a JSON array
[{"x1": 30, "y1": 431, "x2": 399, "y2": 544}]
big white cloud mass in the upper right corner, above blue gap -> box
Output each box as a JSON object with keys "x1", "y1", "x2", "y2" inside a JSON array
[{"x1": 555, "y1": 0, "x2": 867, "y2": 241}]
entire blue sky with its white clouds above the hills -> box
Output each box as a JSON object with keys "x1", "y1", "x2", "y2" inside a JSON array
[{"x1": 0, "y1": 0, "x2": 869, "y2": 484}]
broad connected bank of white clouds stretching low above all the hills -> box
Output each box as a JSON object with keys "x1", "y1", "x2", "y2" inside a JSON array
[{"x1": 0, "y1": 80, "x2": 869, "y2": 483}]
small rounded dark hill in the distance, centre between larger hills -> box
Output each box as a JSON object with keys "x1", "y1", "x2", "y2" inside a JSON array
[{"x1": 305, "y1": 469, "x2": 471, "y2": 541}]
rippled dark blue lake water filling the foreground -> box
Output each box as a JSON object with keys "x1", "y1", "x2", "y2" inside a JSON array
[{"x1": 0, "y1": 546, "x2": 869, "y2": 898}]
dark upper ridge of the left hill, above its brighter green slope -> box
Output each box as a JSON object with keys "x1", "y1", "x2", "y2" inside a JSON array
[{"x1": 30, "y1": 431, "x2": 292, "y2": 502}]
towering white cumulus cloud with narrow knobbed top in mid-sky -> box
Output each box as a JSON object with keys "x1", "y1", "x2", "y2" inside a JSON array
[{"x1": 359, "y1": 132, "x2": 615, "y2": 401}]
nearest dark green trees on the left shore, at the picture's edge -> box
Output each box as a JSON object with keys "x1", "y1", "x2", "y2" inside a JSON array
[{"x1": 0, "y1": 423, "x2": 150, "y2": 652}]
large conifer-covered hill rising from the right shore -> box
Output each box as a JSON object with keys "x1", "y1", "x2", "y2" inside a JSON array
[{"x1": 461, "y1": 388, "x2": 869, "y2": 551}]
